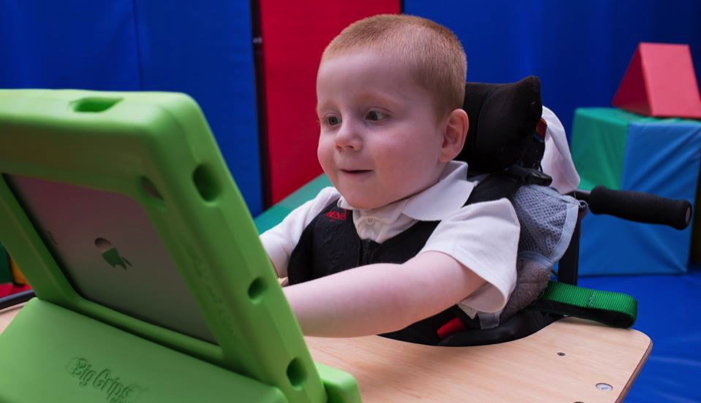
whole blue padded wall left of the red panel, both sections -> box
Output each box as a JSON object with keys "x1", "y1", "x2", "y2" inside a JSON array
[{"x1": 0, "y1": 0, "x2": 262, "y2": 215}]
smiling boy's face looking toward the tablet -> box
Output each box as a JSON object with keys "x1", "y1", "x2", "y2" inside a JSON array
[{"x1": 316, "y1": 52, "x2": 444, "y2": 209}]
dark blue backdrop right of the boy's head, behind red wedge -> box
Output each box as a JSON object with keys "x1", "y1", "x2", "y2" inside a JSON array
[{"x1": 403, "y1": 0, "x2": 701, "y2": 135}]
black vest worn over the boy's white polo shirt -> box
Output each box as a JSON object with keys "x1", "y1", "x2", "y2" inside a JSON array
[{"x1": 287, "y1": 201, "x2": 479, "y2": 345}]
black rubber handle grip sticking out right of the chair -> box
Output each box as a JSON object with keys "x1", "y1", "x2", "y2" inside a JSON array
[{"x1": 588, "y1": 186, "x2": 691, "y2": 230}]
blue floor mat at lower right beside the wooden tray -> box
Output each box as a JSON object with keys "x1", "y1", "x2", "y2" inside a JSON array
[{"x1": 579, "y1": 266, "x2": 701, "y2": 403}]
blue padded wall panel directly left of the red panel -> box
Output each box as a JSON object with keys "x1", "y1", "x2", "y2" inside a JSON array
[{"x1": 134, "y1": 0, "x2": 262, "y2": 216}]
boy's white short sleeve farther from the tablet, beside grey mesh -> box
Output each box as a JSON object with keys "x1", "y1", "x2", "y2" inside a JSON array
[{"x1": 419, "y1": 199, "x2": 520, "y2": 316}]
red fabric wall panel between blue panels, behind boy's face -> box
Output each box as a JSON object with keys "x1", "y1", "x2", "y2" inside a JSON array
[{"x1": 258, "y1": 0, "x2": 400, "y2": 203}]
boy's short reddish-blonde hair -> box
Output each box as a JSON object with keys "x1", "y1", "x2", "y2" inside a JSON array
[{"x1": 321, "y1": 14, "x2": 467, "y2": 119}]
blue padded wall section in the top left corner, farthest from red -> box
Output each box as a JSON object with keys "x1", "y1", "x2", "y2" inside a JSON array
[{"x1": 0, "y1": 0, "x2": 140, "y2": 91}]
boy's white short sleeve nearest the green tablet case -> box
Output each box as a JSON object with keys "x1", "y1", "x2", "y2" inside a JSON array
[{"x1": 260, "y1": 187, "x2": 340, "y2": 277}]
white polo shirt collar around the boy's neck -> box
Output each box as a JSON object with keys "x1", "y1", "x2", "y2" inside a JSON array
[{"x1": 337, "y1": 161, "x2": 475, "y2": 222}]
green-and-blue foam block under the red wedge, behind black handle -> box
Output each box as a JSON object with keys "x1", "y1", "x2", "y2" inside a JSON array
[{"x1": 572, "y1": 108, "x2": 701, "y2": 275}]
